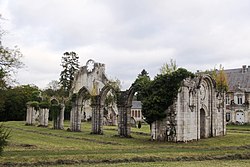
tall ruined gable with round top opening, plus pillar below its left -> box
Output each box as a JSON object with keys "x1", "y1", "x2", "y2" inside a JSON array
[{"x1": 70, "y1": 60, "x2": 108, "y2": 131}]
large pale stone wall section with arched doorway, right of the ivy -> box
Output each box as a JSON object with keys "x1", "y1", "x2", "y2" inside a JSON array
[{"x1": 148, "y1": 75, "x2": 226, "y2": 142}]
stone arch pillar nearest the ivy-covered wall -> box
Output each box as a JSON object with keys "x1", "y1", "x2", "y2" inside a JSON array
[{"x1": 117, "y1": 91, "x2": 131, "y2": 137}]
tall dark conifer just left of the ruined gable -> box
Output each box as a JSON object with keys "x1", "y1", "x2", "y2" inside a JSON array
[{"x1": 60, "y1": 52, "x2": 79, "y2": 96}]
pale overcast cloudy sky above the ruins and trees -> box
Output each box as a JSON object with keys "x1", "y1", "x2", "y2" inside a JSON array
[{"x1": 0, "y1": 0, "x2": 250, "y2": 89}]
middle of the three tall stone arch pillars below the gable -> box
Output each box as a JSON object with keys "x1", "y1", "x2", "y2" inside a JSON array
[{"x1": 91, "y1": 95, "x2": 104, "y2": 134}]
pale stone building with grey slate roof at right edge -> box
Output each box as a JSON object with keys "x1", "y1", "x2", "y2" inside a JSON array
[{"x1": 224, "y1": 65, "x2": 250, "y2": 124}]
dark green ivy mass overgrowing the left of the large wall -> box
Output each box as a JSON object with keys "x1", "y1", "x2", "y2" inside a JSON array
[{"x1": 133, "y1": 65, "x2": 194, "y2": 124}]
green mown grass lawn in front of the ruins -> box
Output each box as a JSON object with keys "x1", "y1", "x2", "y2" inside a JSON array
[{"x1": 0, "y1": 122, "x2": 250, "y2": 166}]
